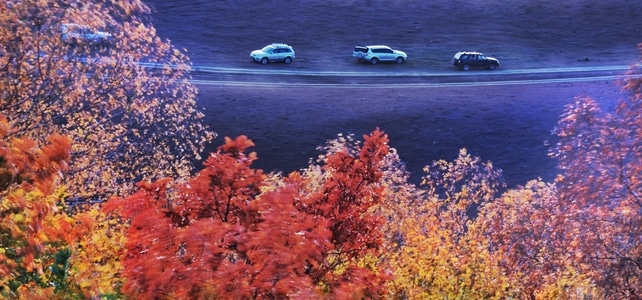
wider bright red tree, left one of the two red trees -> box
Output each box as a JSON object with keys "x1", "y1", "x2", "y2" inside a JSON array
[{"x1": 106, "y1": 137, "x2": 327, "y2": 299}]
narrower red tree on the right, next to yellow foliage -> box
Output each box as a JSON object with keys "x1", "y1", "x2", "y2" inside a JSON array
[{"x1": 288, "y1": 129, "x2": 390, "y2": 298}]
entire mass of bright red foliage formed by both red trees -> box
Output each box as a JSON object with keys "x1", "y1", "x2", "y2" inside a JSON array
[{"x1": 105, "y1": 131, "x2": 387, "y2": 299}]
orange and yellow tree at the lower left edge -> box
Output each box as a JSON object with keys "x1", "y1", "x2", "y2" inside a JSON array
[{"x1": 0, "y1": 113, "x2": 78, "y2": 299}]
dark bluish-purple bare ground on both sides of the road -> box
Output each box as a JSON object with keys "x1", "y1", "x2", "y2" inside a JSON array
[{"x1": 151, "y1": 0, "x2": 642, "y2": 186}]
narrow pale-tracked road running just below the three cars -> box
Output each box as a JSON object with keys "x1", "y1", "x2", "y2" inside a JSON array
[{"x1": 192, "y1": 66, "x2": 628, "y2": 89}]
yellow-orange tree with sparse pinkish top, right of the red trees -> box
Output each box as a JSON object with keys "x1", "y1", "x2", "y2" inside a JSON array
[{"x1": 384, "y1": 149, "x2": 509, "y2": 299}]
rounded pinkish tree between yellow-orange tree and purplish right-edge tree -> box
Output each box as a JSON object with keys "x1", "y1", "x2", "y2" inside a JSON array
[{"x1": 476, "y1": 179, "x2": 604, "y2": 299}]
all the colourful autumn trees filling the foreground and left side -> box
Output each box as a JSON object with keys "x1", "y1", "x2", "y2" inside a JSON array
[{"x1": 0, "y1": 0, "x2": 642, "y2": 299}]
